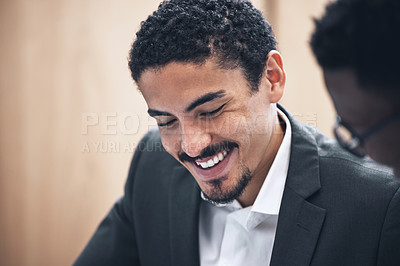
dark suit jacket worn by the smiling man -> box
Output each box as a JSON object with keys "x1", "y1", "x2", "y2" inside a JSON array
[{"x1": 75, "y1": 107, "x2": 400, "y2": 266}]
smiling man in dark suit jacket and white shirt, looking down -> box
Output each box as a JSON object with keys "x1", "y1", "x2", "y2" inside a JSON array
[{"x1": 75, "y1": 0, "x2": 400, "y2": 266}]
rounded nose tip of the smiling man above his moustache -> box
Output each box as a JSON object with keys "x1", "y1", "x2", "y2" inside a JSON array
[{"x1": 181, "y1": 126, "x2": 211, "y2": 157}]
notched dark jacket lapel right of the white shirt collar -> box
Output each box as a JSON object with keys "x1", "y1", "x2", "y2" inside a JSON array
[{"x1": 270, "y1": 106, "x2": 325, "y2": 266}]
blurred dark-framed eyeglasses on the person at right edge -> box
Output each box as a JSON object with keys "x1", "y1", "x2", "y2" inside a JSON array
[{"x1": 333, "y1": 113, "x2": 400, "y2": 157}]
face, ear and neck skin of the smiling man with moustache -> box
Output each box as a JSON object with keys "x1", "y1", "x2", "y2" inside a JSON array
[{"x1": 138, "y1": 59, "x2": 284, "y2": 206}]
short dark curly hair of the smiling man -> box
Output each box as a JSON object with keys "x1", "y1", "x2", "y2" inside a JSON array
[{"x1": 129, "y1": 0, "x2": 276, "y2": 91}]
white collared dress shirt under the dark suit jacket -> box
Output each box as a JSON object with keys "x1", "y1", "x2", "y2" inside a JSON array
[{"x1": 199, "y1": 110, "x2": 292, "y2": 266}]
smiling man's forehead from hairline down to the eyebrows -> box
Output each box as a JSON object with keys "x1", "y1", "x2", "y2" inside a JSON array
[{"x1": 138, "y1": 62, "x2": 250, "y2": 116}]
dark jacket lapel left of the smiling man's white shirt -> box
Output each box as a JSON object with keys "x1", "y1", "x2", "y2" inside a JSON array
[{"x1": 169, "y1": 166, "x2": 200, "y2": 266}]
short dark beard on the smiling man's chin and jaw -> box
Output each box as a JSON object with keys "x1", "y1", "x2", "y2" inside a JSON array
[{"x1": 203, "y1": 167, "x2": 253, "y2": 204}]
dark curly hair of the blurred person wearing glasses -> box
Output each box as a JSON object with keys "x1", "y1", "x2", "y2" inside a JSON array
[{"x1": 311, "y1": 0, "x2": 400, "y2": 95}]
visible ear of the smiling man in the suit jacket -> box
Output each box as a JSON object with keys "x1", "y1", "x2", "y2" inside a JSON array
[{"x1": 264, "y1": 50, "x2": 286, "y2": 103}]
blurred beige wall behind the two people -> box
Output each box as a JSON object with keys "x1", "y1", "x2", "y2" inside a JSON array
[{"x1": 0, "y1": 0, "x2": 334, "y2": 266}]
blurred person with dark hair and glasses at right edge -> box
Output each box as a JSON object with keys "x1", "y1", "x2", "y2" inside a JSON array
[{"x1": 311, "y1": 0, "x2": 400, "y2": 176}]
